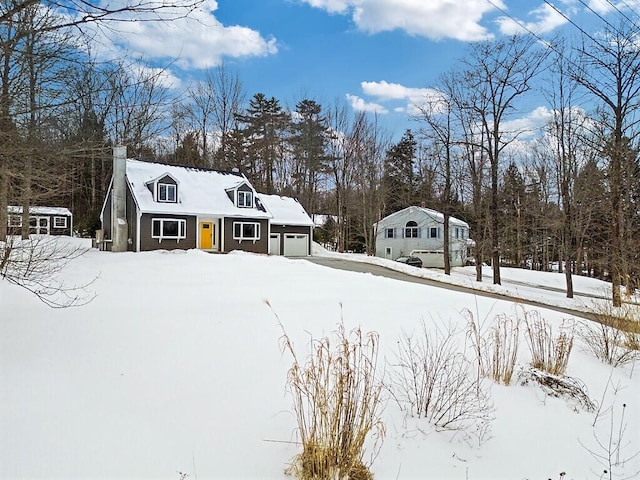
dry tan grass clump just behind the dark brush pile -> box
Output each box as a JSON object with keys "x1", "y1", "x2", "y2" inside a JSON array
[{"x1": 525, "y1": 311, "x2": 574, "y2": 375}]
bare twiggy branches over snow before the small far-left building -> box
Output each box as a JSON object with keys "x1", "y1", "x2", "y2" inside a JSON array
[{"x1": 0, "y1": 235, "x2": 95, "y2": 308}]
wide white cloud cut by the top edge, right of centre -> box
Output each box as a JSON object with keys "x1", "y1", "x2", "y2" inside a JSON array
[{"x1": 302, "y1": 0, "x2": 506, "y2": 41}]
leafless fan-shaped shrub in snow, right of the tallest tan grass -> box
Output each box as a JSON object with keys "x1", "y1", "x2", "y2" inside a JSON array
[{"x1": 388, "y1": 322, "x2": 493, "y2": 433}]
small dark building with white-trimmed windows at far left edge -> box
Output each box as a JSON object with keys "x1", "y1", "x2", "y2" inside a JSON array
[{"x1": 7, "y1": 205, "x2": 73, "y2": 235}]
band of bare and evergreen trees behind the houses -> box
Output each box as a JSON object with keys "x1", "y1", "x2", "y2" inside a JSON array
[{"x1": 0, "y1": 2, "x2": 640, "y2": 303}]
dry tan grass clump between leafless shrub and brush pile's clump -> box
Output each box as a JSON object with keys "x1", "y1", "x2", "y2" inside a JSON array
[{"x1": 463, "y1": 310, "x2": 520, "y2": 385}]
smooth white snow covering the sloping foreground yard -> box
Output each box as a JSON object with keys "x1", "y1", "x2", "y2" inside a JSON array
[{"x1": 0, "y1": 238, "x2": 640, "y2": 480}]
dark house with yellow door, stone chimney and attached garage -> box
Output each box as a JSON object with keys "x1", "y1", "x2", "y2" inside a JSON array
[{"x1": 98, "y1": 147, "x2": 313, "y2": 256}]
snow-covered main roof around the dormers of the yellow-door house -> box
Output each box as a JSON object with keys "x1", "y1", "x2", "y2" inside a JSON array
[{"x1": 127, "y1": 159, "x2": 271, "y2": 218}]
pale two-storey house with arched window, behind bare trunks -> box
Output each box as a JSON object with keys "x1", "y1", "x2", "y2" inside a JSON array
[{"x1": 373, "y1": 207, "x2": 473, "y2": 268}]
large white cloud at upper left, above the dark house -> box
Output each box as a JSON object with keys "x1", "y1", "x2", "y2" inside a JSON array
[{"x1": 79, "y1": 0, "x2": 278, "y2": 69}]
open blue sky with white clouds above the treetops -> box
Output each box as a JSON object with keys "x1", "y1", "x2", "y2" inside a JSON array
[{"x1": 92, "y1": 0, "x2": 640, "y2": 141}]
